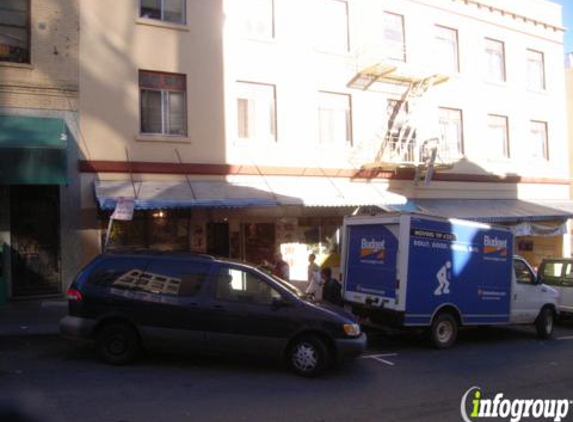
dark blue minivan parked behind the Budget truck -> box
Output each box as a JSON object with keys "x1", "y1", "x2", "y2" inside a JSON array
[{"x1": 60, "y1": 251, "x2": 366, "y2": 376}]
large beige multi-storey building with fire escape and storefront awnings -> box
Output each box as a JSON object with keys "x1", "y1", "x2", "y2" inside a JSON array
[{"x1": 73, "y1": 0, "x2": 572, "y2": 286}]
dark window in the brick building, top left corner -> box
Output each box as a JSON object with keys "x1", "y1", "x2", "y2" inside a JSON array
[{"x1": 0, "y1": 0, "x2": 30, "y2": 63}]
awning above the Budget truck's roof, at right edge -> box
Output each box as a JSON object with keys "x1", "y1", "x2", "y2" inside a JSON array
[{"x1": 415, "y1": 199, "x2": 573, "y2": 223}]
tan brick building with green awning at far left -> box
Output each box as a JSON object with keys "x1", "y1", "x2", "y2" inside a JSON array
[{"x1": 0, "y1": 0, "x2": 81, "y2": 302}]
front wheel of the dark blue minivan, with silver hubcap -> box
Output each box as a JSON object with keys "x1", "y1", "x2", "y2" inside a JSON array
[{"x1": 287, "y1": 336, "x2": 328, "y2": 377}]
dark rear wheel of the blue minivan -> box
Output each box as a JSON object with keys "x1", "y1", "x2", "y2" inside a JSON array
[{"x1": 96, "y1": 322, "x2": 140, "y2": 365}]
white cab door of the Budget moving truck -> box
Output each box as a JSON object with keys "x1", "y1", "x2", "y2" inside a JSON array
[{"x1": 511, "y1": 259, "x2": 544, "y2": 324}]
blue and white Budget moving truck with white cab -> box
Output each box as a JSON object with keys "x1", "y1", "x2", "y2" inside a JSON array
[{"x1": 341, "y1": 213, "x2": 558, "y2": 348}]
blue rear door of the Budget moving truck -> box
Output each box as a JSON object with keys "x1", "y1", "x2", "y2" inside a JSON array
[{"x1": 344, "y1": 222, "x2": 399, "y2": 306}]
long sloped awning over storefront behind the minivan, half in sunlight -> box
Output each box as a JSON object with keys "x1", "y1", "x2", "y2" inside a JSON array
[{"x1": 95, "y1": 177, "x2": 409, "y2": 210}]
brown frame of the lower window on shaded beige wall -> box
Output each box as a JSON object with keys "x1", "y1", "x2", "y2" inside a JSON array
[{"x1": 138, "y1": 69, "x2": 189, "y2": 139}]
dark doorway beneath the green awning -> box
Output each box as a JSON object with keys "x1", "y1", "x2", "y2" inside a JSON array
[{"x1": 10, "y1": 185, "x2": 61, "y2": 297}]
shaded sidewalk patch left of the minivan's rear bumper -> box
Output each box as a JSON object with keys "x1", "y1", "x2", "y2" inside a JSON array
[{"x1": 0, "y1": 298, "x2": 68, "y2": 337}]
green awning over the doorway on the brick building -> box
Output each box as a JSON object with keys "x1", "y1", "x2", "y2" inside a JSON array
[{"x1": 0, "y1": 115, "x2": 72, "y2": 185}]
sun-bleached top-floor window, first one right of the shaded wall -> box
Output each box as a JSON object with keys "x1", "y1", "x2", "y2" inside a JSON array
[{"x1": 235, "y1": 0, "x2": 275, "y2": 40}]
